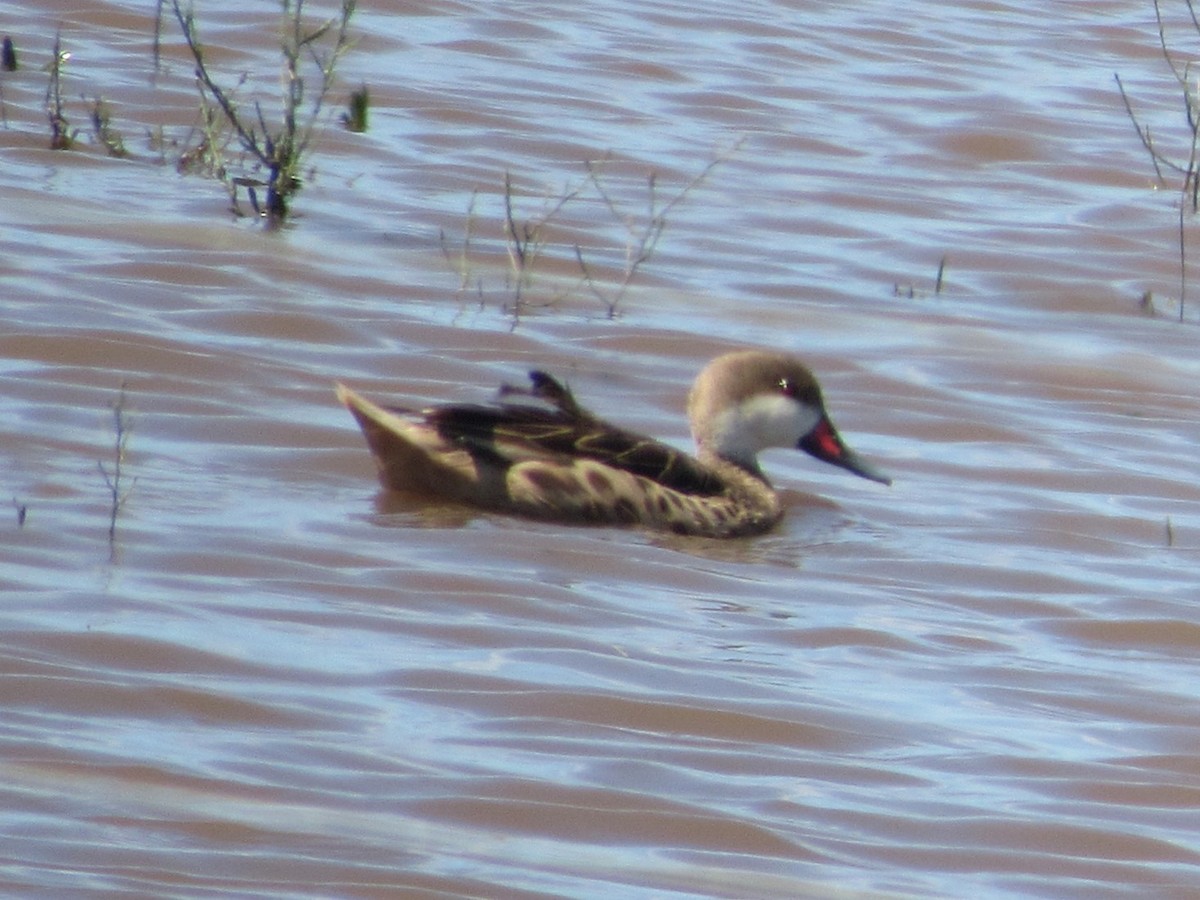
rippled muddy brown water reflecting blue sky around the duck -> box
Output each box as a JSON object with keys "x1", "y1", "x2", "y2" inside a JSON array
[{"x1": 0, "y1": 0, "x2": 1200, "y2": 898}]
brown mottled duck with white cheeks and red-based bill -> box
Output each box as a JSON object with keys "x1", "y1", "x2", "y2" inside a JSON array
[{"x1": 336, "y1": 349, "x2": 892, "y2": 538}]
